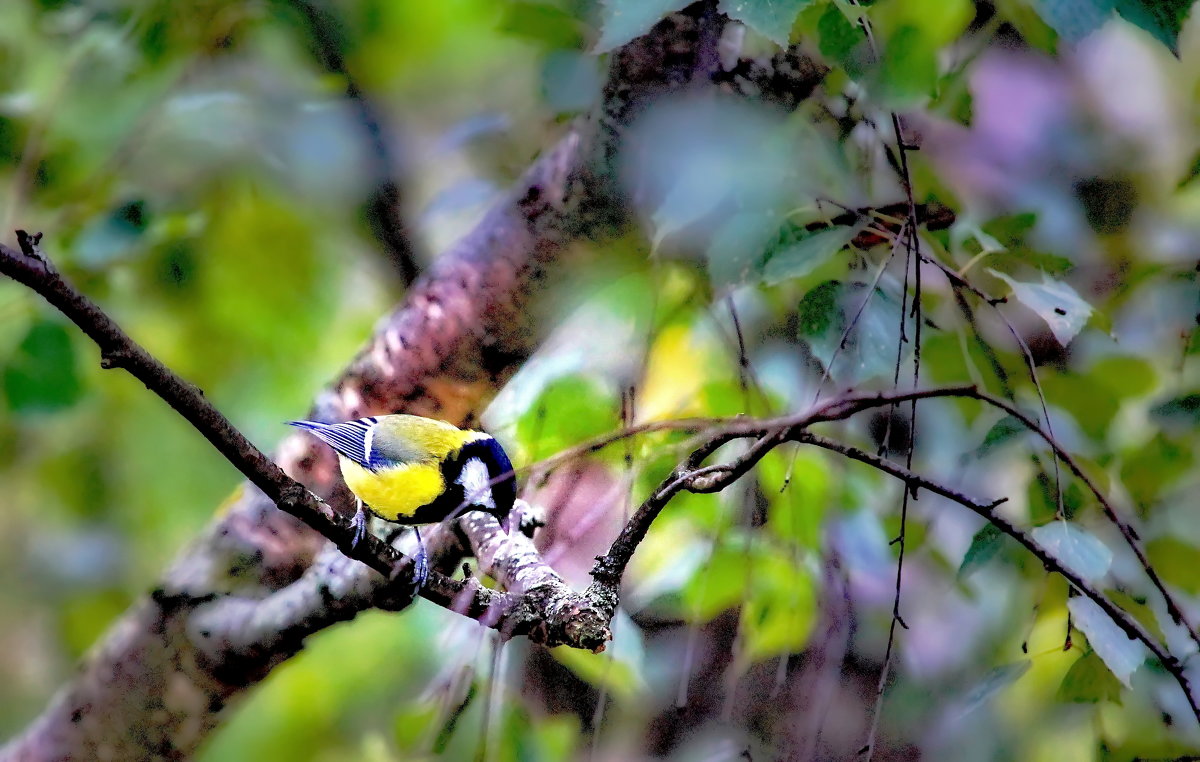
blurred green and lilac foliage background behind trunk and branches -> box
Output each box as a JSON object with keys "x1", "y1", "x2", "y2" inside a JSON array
[{"x1": 0, "y1": 0, "x2": 1200, "y2": 761}]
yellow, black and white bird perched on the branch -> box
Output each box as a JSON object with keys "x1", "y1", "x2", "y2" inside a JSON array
[{"x1": 288, "y1": 414, "x2": 517, "y2": 589}]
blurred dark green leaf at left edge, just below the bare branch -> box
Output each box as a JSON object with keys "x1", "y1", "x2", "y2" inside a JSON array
[{"x1": 4, "y1": 319, "x2": 83, "y2": 414}]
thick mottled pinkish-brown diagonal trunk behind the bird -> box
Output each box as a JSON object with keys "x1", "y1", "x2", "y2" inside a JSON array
[{"x1": 0, "y1": 8, "x2": 820, "y2": 760}]
